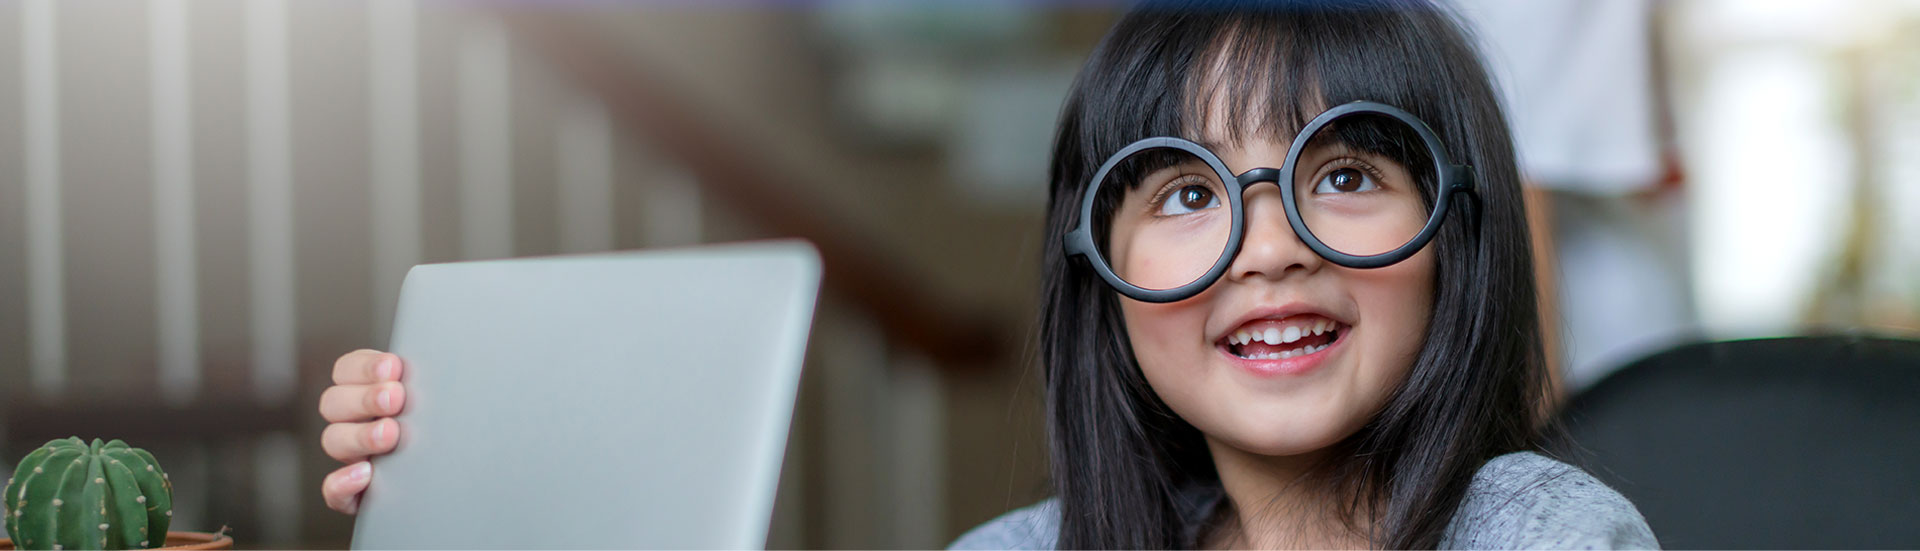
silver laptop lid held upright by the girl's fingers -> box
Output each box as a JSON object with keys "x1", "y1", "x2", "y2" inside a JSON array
[{"x1": 353, "y1": 240, "x2": 820, "y2": 549}]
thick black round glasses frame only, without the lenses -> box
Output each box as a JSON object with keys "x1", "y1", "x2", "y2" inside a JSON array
[{"x1": 1064, "y1": 102, "x2": 1478, "y2": 301}]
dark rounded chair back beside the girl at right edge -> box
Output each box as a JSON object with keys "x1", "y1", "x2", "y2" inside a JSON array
[{"x1": 1561, "y1": 336, "x2": 1920, "y2": 549}]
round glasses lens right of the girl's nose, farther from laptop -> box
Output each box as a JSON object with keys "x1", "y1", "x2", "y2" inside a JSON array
[{"x1": 1292, "y1": 113, "x2": 1438, "y2": 255}]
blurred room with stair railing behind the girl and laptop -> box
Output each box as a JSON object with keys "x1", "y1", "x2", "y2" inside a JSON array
[{"x1": 0, "y1": 0, "x2": 1920, "y2": 547}]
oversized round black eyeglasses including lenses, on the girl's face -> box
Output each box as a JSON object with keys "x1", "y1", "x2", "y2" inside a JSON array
[{"x1": 1064, "y1": 102, "x2": 1475, "y2": 301}]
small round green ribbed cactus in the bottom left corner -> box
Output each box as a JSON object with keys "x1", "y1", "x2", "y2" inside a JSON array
[{"x1": 0, "y1": 438, "x2": 173, "y2": 549}]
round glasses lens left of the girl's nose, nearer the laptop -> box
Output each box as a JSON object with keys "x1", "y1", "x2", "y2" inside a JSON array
[{"x1": 1092, "y1": 148, "x2": 1233, "y2": 290}]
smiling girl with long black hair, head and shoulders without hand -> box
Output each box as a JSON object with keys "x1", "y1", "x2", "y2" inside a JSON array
[{"x1": 952, "y1": 2, "x2": 1657, "y2": 549}]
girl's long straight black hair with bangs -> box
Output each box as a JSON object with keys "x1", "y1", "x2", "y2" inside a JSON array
[{"x1": 1041, "y1": 2, "x2": 1546, "y2": 549}]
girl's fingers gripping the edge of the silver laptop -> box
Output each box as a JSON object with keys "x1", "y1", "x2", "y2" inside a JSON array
[{"x1": 321, "y1": 349, "x2": 407, "y2": 515}]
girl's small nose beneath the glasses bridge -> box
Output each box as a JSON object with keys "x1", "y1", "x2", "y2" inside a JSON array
[{"x1": 1227, "y1": 182, "x2": 1327, "y2": 280}]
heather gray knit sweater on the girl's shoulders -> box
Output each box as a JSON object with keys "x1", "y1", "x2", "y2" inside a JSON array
[{"x1": 948, "y1": 451, "x2": 1659, "y2": 549}]
